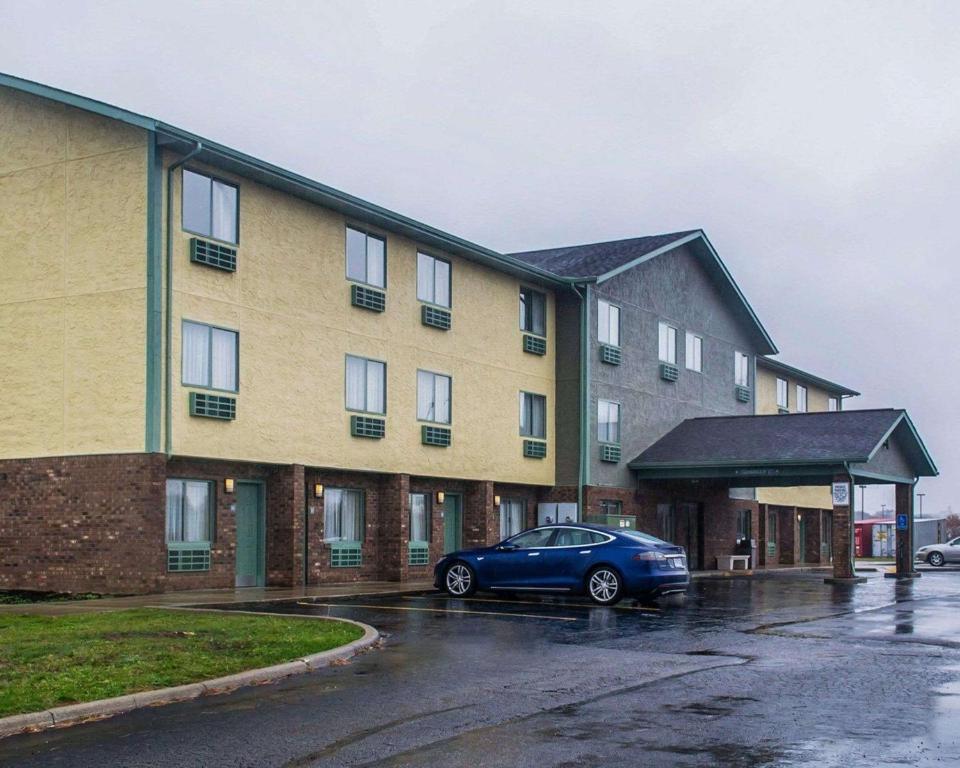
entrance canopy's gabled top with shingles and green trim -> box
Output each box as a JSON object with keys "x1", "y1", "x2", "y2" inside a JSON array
[{"x1": 629, "y1": 408, "x2": 938, "y2": 487}]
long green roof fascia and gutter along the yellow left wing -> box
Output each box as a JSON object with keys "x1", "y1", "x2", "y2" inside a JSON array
[{"x1": 0, "y1": 73, "x2": 568, "y2": 286}]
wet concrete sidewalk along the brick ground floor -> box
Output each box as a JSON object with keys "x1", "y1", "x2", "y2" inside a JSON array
[{"x1": 0, "y1": 581, "x2": 433, "y2": 616}]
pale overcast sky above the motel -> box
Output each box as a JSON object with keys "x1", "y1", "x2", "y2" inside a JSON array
[{"x1": 0, "y1": 0, "x2": 960, "y2": 514}]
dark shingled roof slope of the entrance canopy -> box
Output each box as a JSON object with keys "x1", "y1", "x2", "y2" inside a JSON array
[{"x1": 630, "y1": 408, "x2": 906, "y2": 469}]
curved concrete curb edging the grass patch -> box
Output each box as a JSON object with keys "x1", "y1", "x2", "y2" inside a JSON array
[{"x1": 0, "y1": 606, "x2": 380, "y2": 739}]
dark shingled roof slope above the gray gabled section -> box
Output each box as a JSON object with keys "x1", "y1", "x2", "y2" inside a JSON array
[{"x1": 507, "y1": 229, "x2": 700, "y2": 277}]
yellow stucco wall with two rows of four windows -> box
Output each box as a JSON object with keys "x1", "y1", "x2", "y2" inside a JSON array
[{"x1": 171, "y1": 158, "x2": 556, "y2": 485}]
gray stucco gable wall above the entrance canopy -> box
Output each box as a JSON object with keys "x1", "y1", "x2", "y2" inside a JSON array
[{"x1": 584, "y1": 246, "x2": 756, "y2": 487}]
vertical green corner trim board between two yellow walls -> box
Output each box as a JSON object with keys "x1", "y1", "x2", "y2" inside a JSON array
[{"x1": 144, "y1": 131, "x2": 163, "y2": 453}]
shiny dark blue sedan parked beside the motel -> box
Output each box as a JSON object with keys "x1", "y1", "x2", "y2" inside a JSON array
[{"x1": 434, "y1": 523, "x2": 690, "y2": 605}]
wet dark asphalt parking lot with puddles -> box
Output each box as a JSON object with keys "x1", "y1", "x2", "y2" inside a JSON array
[{"x1": 0, "y1": 570, "x2": 960, "y2": 768}]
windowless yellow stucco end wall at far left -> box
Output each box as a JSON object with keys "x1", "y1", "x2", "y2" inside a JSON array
[{"x1": 0, "y1": 87, "x2": 146, "y2": 458}]
